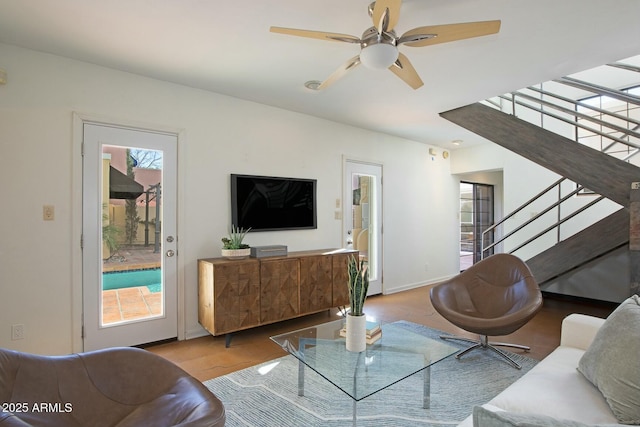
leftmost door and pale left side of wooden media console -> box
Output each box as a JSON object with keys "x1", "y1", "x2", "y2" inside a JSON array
[{"x1": 198, "y1": 260, "x2": 260, "y2": 335}]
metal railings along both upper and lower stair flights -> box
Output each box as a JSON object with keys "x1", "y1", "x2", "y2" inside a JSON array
[{"x1": 481, "y1": 63, "x2": 640, "y2": 258}]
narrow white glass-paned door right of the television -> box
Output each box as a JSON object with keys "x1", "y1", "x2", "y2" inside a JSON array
[{"x1": 343, "y1": 160, "x2": 383, "y2": 295}]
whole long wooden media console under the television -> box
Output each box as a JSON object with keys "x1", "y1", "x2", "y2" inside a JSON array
[{"x1": 198, "y1": 250, "x2": 358, "y2": 338}]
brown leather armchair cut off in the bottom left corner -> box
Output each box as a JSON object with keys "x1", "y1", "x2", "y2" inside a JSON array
[{"x1": 0, "y1": 348, "x2": 225, "y2": 427}]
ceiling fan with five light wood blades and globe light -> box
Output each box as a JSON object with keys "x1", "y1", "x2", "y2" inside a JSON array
[{"x1": 270, "y1": 0, "x2": 500, "y2": 90}]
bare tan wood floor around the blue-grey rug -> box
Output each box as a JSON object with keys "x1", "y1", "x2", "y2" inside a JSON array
[{"x1": 147, "y1": 286, "x2": 614, "y2": 381}]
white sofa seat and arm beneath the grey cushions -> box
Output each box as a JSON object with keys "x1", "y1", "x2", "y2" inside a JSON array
[{"x1": 459, "y1": 314, "x2": 618, "y2": 427}]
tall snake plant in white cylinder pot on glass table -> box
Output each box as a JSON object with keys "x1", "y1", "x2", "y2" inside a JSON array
[{"x1": 346, "y1": 256, "x2": 369, "y2": 352}]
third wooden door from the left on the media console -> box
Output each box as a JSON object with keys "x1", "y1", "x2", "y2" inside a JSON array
[{"x1": 300, "y1": 255, "x2": 332, "y2": 314}]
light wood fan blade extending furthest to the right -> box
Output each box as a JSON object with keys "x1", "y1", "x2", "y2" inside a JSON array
[{"x1": 398, "y1": 20, "x2": 500, "y2": 47}]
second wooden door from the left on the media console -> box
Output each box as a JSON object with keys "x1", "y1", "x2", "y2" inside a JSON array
[{"x1": 260, "y1": 258, "x2": 300, "y2": 323}]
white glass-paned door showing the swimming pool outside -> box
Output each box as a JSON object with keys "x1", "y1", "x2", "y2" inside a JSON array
[{"x1": 82, "y1": 123, "x2": 178, "y2": 351}]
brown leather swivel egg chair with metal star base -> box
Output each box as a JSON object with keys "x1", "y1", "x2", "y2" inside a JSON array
[{"x1": 430, "y1": 254, "x2": 542, "y2": 369}]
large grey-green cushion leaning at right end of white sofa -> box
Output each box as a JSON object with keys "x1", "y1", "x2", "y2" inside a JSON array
[{"x1": 578, "y1": 295, "x2": 640, "y2": 424}]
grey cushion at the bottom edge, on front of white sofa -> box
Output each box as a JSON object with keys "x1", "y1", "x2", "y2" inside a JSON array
[{"x1": 473, "y1": 406, "x2": 618, "y2": 427}]
